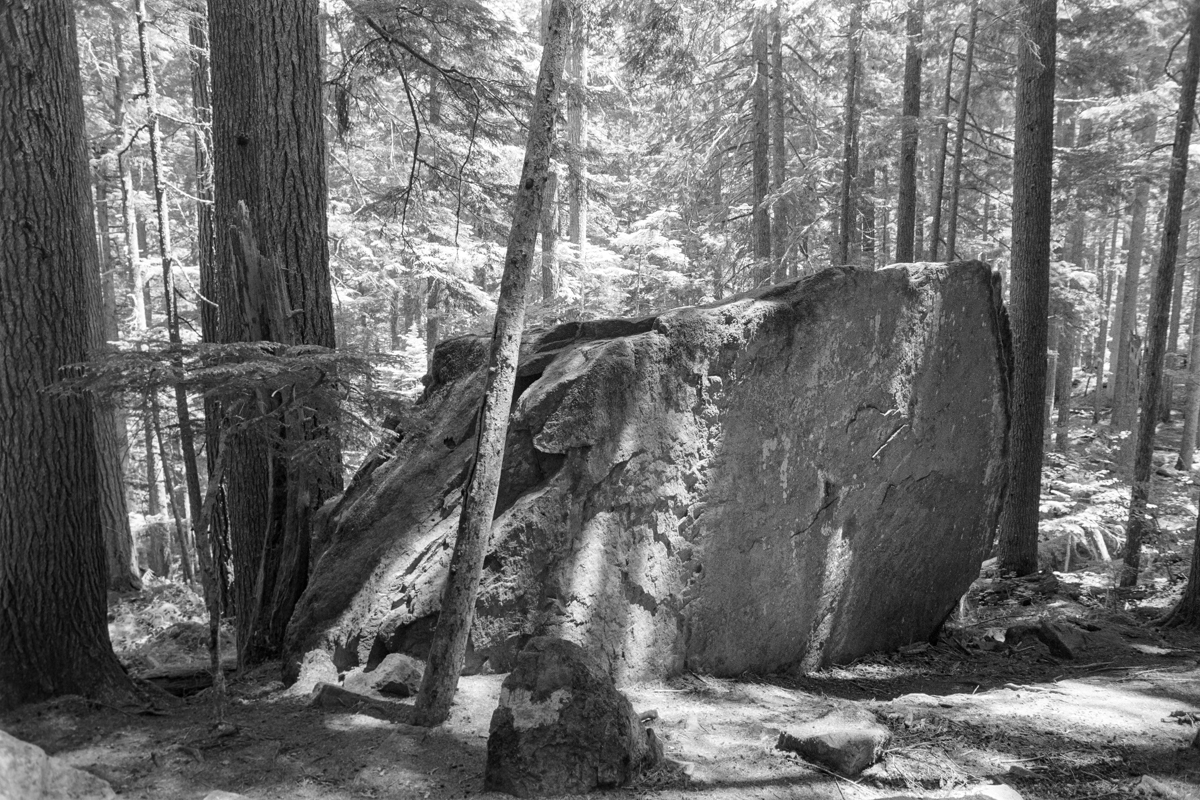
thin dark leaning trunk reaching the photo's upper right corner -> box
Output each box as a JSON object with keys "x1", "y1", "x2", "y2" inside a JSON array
[{"x1": 1121, "y1": 0, "x2": 1200, "y2": 587}]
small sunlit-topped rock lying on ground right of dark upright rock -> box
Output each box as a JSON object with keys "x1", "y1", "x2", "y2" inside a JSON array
[{"x1": 775, "y1": 709, "x2": 892, "y2": 777}]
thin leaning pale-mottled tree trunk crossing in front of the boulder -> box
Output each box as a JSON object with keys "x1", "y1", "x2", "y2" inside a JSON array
[{"x1": 415, "y1": 0, "x2": 570, "y2": 726}]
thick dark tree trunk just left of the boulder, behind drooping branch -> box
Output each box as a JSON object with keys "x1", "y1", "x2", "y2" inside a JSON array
[{"x1": 209, "y1": 0, "x2": 341, "y2": 666}]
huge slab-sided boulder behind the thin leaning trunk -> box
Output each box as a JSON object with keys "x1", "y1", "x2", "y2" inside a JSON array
[{"x1": 284, "y1": 263, "x2": 1009, "y2": 681}]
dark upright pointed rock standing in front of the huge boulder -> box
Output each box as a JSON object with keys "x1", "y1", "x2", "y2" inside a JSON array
[{"x1": 484, "y1": 637, "x2": 662, "y2": 798}]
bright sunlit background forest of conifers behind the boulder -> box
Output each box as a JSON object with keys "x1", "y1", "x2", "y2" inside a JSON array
[{"x1": 78, "y1": 0, "x2": 1195, "y2": 599}]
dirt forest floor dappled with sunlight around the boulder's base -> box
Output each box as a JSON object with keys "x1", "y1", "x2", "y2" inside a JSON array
[{"x1": 7, "y1": 417, "x2": 1200, "y2": 800}]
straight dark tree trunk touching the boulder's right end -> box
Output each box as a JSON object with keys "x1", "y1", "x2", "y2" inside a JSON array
[{"x1": 1000, "y1": 0, "x2": 1057, "y2": 575}]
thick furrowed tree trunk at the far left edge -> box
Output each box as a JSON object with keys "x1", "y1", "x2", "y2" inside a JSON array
[{"x1": 0, "y1": 0, "x2": 132, "y2": 710}]
